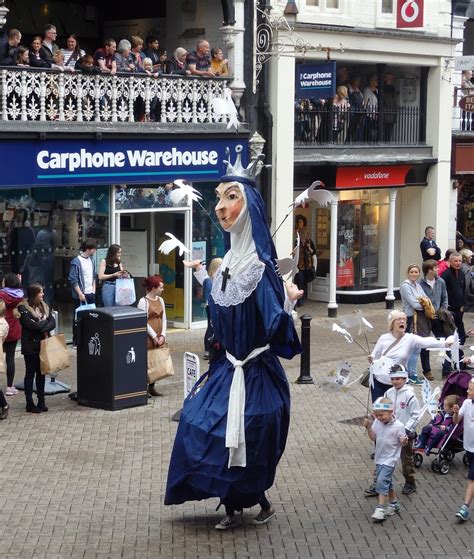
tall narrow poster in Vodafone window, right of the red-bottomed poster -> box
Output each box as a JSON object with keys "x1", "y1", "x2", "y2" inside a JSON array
[{"x1": 360, "y1": 204, "x2": 379, "y2": 286}]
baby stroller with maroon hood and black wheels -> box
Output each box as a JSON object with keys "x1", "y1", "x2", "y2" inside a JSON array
[{"x1": 413, "y1": 371, "x2": 472, "y2": 475}]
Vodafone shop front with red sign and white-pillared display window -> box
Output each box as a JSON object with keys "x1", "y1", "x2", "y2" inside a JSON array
[{"x1": 299, "y1": 165, "x2": 432, "y2": 316}]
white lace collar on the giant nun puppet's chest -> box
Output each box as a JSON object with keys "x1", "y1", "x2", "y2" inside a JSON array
[{"x1": 211, "y1": 260, "x2": 265, "y2": 307}]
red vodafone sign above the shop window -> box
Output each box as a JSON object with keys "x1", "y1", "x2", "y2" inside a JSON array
[{"x1": 336, "y1": 165, "x2": 410, "y2": 188}]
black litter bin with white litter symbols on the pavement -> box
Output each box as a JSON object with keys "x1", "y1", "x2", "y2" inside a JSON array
[{"x1": 77, "y1": 307, "x2": 147, "y2": 410}]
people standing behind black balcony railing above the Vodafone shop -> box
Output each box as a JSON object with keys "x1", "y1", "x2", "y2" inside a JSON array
[{"x1": 295, "y1": 66, "x2": 398, "y2": 143}]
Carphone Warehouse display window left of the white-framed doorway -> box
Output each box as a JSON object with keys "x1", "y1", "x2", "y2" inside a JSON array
[{"x1": 0, "y1": 186, "x2": 109, "y2": 335}]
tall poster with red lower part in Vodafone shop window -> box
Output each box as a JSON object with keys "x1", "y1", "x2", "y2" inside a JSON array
[{"x1": 336, "y1": 201, "x2": 356, "y2": 287}]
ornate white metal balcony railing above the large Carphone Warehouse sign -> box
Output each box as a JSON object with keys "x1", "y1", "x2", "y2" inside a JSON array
[{"x1": 0, "y1": 68, "x2": 228, "y2": 124}]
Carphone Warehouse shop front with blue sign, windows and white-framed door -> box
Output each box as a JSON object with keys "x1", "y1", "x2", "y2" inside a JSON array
[{"x1": 0, "y1": 135, "x2": 247, "y2": 337}]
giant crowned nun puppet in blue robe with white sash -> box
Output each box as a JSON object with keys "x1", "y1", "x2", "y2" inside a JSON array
[{"x1": 165, "y1": 148, "x2": 302, "y2": 530}]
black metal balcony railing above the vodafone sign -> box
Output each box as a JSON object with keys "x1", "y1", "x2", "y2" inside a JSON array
[{"x1": 295, "y1": 105, "x2": 423, "y2": 146}]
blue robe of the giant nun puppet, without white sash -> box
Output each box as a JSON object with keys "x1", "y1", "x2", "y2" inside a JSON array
[{"x1": 165, "y1": 264, "x2": 301, "y2": 509}]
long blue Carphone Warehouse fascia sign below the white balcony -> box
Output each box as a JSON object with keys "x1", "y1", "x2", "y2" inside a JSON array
[{"x1": 0, "y1": 139, "x2": 246, "y2": 187}]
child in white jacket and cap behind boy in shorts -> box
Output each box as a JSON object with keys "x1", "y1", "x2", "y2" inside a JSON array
[{"x1": 384, "y1": 365, "x2": 420, "y2": 495}]
